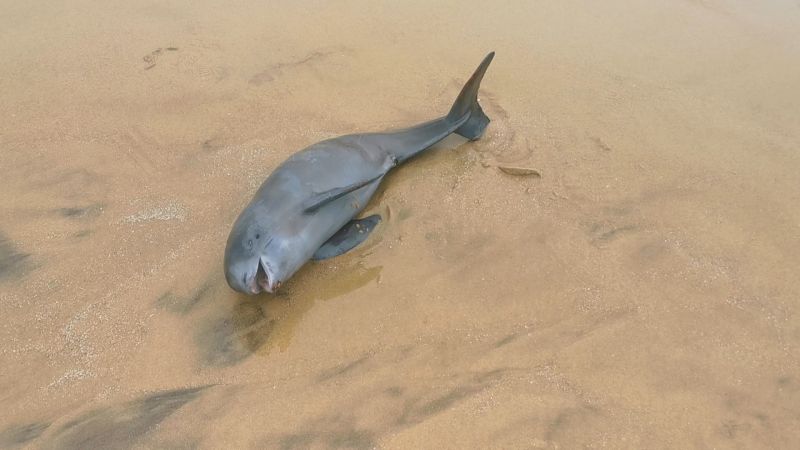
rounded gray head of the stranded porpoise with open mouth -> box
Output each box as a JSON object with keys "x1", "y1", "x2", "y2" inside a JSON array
[{"x1": 224, "y1": 212, "x2": 284, "y2": 295}]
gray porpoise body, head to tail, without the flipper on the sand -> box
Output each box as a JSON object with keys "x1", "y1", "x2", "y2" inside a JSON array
[{"x1": 224, "y1": 52, "x2": 494, "y2": 295}]
